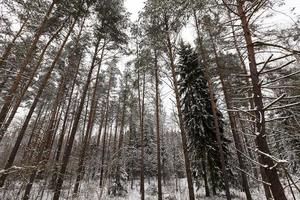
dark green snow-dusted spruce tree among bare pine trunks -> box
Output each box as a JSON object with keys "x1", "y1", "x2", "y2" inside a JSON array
[{"x1": 178, "y1": 43, "x2": 229, "y2": 196}]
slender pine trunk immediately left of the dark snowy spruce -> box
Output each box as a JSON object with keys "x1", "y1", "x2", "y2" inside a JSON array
[{"x1": 165, "y1": 16, "x2": 195, "y2": 200}]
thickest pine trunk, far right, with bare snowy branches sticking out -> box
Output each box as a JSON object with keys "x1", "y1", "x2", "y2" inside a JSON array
[{"x1": 237, "y1": 0, "x2": 287, "y2": 200}]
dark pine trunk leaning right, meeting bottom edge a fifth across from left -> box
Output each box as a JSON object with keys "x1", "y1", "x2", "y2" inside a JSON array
[{"x1": 53, "y1": 39, "x2": 104, "y2": 200}]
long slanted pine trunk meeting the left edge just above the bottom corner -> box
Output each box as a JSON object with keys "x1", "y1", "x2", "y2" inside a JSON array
[{"x1": 0, "y1": 20, "x2": 76, "y2": 187}]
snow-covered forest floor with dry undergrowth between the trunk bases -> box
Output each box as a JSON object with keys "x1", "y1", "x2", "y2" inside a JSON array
[{"x1": 0, "y1": 179, "x2": 300, "y2": 200}]
